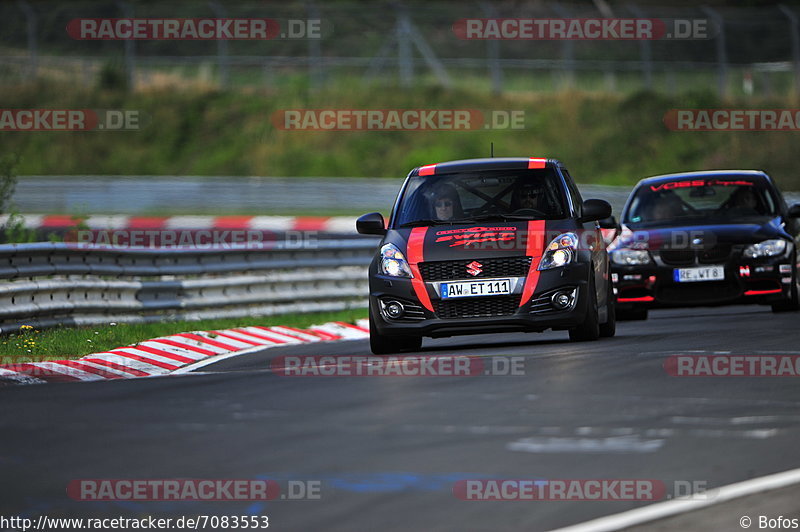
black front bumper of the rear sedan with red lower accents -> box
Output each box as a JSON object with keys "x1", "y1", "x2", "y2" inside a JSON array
[{"x1": 611, "y1": 254, "x2": 793, "y2": 310}]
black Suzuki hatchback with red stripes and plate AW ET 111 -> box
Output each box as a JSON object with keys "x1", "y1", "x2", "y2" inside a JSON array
[{"x1": 356, "y1": 157, "x2": 616, "y2": 354}]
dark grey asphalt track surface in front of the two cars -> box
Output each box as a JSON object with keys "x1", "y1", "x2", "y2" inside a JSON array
[{"x1": 0, "y1": 306, "x2": 800, "y2": 530}]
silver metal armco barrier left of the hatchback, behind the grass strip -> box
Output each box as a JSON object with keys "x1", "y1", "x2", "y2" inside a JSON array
[{"x1": 0, "y1": 238, "x2": 377, "y2": 333}]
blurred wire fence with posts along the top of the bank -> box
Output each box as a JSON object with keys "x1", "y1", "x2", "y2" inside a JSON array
[{"x1": 0, "y1": 0, "x2": 800, "y2": 96}]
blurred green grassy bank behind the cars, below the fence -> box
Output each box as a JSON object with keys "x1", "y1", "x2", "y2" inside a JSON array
[{"x1": 0, "y1": 83, "x2": 800, "y2": 190}]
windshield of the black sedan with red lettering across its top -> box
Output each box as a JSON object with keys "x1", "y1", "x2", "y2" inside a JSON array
[{"x1": 623, "y1": 175, "x2": 776, "y2": 227}]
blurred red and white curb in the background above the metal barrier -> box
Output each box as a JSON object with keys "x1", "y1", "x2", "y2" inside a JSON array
[{"x1": 0, "y1": 214, "x2": 356, "y2": 233}]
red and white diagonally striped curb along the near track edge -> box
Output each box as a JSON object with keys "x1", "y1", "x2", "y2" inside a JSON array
[{"x1": 0, "y1": 320, "x2": 369, "y2": 384}]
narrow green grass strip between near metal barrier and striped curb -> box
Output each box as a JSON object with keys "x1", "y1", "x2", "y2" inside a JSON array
[{"x1": 0, "y1": 309, "x2": 367, "y2": 364}]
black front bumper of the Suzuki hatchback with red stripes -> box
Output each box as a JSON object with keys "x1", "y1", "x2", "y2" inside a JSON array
[{"x1": 370, "y1": 263, "x2": 590, "y2": 337}]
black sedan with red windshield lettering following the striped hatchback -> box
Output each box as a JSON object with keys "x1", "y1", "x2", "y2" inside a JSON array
[{"x1": 610, "y1": 170, "x2": 800, "y2": 319}]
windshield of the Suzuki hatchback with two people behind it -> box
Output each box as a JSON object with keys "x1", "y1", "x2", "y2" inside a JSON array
[{"x1": 395, "y1": 168, "x2": 566, "y2": 227}]
